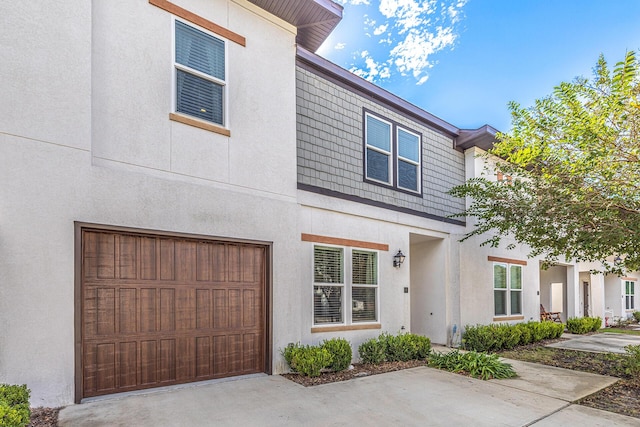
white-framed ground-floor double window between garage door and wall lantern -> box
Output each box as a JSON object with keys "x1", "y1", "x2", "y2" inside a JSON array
[{"x1": 313, "y1": 245, "x2": 378, "y2": 325}]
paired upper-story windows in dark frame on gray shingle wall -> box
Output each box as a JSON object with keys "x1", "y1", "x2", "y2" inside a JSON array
[{"x1": 364, "y1": 112, "x2": 422, "y2": 193}]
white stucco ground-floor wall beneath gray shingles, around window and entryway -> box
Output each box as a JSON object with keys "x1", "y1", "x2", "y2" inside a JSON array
[{"x1": 298, "y1": 191, "x2": 461, "y2": 360}]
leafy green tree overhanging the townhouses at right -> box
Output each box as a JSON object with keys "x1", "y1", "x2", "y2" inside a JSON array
[{"x1": 451, "y1": 52, "x2": 640, "y2": 272}]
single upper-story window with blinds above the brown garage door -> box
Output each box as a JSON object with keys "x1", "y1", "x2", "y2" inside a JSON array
[{"x1": 174, "y1": 19, "x2": 227, "y2": 126}]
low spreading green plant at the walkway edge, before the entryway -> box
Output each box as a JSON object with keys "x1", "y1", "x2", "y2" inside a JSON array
[{"x1": 429, "y1": 350, "x2": 517, "y2": 380}]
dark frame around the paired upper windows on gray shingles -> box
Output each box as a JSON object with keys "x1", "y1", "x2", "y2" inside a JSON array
[{"x1": 362, "y1": 108, "x2": 424, "y2": 198}]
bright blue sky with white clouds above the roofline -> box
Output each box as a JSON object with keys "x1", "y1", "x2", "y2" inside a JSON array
[{"x1": 318, "y1": 0, "x2": 640, "y2": 131}]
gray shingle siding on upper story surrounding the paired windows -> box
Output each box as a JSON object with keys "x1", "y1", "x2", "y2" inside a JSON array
[{"x1": 296, "y1": 67, "x2": 465, "y2": 221}]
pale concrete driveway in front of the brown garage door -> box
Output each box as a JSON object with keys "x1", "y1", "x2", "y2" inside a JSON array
[{"x1": 59, "y1": 361, "x2": 640, "y2": 427}]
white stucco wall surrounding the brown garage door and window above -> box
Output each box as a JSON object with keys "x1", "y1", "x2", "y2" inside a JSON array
[{"x1": 0, "y1": 0, "x2": 300, "y2": 406}]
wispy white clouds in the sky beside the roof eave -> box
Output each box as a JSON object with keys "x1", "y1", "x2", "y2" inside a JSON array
[{"x1": 346, "y1": 0, "x2": 468, "y2": 85}]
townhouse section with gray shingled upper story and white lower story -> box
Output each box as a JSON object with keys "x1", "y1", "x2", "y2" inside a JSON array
[{"x1": 297, "y1": 47, "x2": 500, "y2": 348}]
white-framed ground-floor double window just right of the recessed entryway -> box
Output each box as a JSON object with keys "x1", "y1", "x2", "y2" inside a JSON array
[{"x1": 493, "y1": 262, "x2": 522, "y2": 316}]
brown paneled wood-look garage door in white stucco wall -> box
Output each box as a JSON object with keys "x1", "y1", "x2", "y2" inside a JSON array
[{"x1": 79, "y1": 229, "x2": 267, "y2": 397}]
